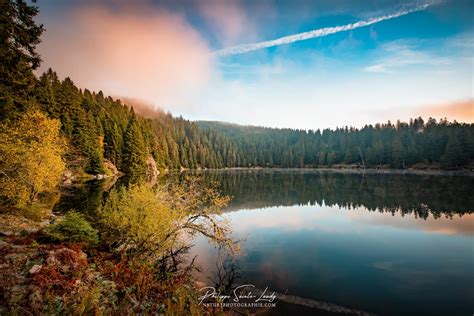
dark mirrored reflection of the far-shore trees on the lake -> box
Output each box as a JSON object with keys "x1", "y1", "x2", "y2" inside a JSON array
[{"x1": 205, "y1": 171, "x2": 474, "y2": 218}]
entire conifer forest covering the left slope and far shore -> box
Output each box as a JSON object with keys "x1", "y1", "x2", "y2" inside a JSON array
[{"x1": 2, "y1": 69, "x2": 474, "y2": 174}]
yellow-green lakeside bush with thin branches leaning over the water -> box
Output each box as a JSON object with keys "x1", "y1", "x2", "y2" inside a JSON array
[{"x1": 100, "y1": 181, "x2": 232, "y2": 260}]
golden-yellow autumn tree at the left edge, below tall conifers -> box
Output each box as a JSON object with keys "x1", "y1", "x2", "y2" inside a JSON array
[{"x1": 0, "y1": 110, "x2": 65, "y2": 207}]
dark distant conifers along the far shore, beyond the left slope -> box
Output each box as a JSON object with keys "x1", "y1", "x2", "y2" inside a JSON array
[{"x1": 198, "y1": 117, "x2": 474, "y2": 168}]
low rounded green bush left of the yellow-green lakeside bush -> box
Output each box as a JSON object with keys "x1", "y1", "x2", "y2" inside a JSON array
[{"x1": 44, "y1": 210, "x2": 99, "y2": 244}]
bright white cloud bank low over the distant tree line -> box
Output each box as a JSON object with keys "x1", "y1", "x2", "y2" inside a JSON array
[{"x1": 180, "y1": 41, "x2": 472, "y2": 129}]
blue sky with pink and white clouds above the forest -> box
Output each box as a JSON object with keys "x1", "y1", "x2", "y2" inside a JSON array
[{"x1": 37, "y1": 0, "x2": 474, "y2": 129}]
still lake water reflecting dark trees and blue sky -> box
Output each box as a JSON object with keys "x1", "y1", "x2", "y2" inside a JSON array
[{"x1": 53, "y1": 171, "x2": 474, "y2": 316}]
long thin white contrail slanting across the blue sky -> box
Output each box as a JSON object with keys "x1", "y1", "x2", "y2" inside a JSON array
[{"x1": 214, "y1": 1, "x2": 439, "y2": 56}]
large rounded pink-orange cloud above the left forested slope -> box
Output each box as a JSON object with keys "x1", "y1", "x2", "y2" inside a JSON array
[{"x1": 40, "y1": 2, "x2": 212, "y2": 109}]
